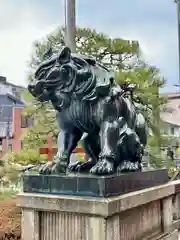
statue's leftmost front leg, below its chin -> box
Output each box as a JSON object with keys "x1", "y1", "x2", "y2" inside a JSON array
[{"x1": 40, "y1": 129, "x2": 82, "y2": 174}]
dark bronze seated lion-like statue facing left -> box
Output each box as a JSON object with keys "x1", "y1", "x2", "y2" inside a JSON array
[{"x1": 28, "y1": 47, "x2": 147, "y2": 175}]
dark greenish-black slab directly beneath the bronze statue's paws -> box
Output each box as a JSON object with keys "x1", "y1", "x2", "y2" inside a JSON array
[{"x1": 23, "y1": 169, "x2": 168, "y2": 198}]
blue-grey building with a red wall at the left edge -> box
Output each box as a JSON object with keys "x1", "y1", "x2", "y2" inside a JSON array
[{"x1": 0, "y1": 93, "x2": 30, "y2": 154}]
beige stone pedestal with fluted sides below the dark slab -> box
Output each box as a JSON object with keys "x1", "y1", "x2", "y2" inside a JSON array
[{"x1": 17, "y1": 170, "x2": 177, "y2": 240}]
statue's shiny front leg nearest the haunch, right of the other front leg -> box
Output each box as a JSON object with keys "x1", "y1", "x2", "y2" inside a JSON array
[{"x1": 90, "y1": 120, "x2": 119, "y2": 175}]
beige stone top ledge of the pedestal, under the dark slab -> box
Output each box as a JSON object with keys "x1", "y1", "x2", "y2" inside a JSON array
[{"x1": 17, "y1": 182, "x2": 174, "y2": 218}]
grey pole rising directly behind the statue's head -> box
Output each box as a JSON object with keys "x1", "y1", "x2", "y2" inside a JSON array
[{"x1": 65, "y1": 0, "x2": 76, "y2": 52}]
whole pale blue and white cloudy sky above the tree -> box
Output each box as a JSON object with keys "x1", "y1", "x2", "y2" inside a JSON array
[{"x1": 0, "y1": 0, "x2": 179, "y2": 92}]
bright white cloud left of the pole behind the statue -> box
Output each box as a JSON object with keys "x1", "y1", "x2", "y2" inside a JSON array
[{"x1": 0, "y1": 0, "x2": 59, "y2": 85}]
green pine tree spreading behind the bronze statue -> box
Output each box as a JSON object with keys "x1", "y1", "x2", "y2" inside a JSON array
[{"x1": 17, "y1": 27, "x2": 165, "y2": 165}]
